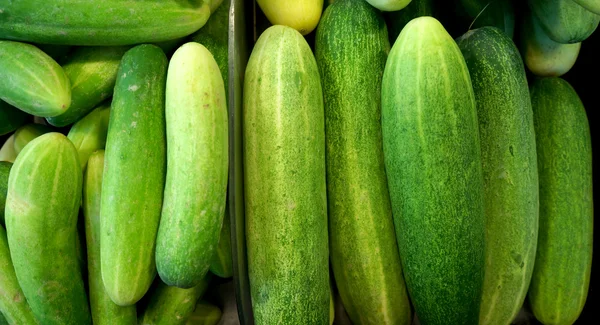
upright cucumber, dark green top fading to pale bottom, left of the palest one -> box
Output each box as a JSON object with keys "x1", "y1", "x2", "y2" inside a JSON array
[{"x1": 100, "y1": 44, "x2": 168, "y2": 306}]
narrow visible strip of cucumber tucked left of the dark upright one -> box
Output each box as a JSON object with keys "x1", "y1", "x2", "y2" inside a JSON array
[{"x1": 83, "y1": 150, "x2": 137, "y2": 325}]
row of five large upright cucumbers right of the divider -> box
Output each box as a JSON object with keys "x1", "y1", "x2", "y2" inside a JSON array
[{"x1": 243, "y1": 0, "x2": 593, "y2": 324}]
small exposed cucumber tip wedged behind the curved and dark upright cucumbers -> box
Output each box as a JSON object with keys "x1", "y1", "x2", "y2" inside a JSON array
[{"x1": 67, "y1": 101, "x2": 110, "y2": 171}]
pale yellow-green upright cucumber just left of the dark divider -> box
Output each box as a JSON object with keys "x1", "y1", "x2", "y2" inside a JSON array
[{"x1": 156, "y1": 42, "x2": 229, "y2": 288}]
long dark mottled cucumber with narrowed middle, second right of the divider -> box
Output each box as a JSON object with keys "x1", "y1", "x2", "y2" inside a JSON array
[{"x1": 315, "y1": 0, "x2": 412, "y2": 324}]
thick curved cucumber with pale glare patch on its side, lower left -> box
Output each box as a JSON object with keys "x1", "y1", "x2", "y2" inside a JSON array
[{"x1": 6, "y1": 132, "x2": 92, "y2": 325}]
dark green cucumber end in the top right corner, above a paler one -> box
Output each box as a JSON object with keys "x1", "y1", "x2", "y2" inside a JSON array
[{"x1": 527, "y1": 0, "x2": 600, "y2": 44}]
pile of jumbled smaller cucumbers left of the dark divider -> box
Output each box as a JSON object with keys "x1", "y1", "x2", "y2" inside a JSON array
[{"x1": 0, "y1": 0, "x2": 233, "y2": 325}]
